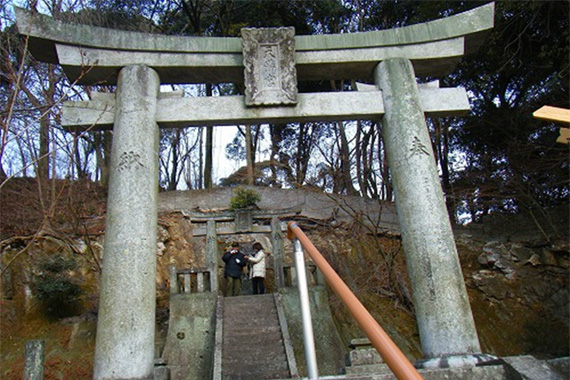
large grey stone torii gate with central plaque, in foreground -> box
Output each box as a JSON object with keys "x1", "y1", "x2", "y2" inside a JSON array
[{"x1": 16, "y1": 3, "x2": 494, "y2": 380}]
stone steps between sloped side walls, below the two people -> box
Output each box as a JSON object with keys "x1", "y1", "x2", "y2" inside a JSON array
[{"x1": 222, "y1": 294, "x2": 291, "y2": 380}]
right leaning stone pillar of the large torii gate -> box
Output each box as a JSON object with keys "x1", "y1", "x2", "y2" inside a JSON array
[{"x1": 374, "y1": 58, "x2": 487, "y2": 367}]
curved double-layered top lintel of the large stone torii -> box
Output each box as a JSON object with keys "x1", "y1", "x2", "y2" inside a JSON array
[{"x1": 15, "y1": 3, "x2": 494, "y2": 84}]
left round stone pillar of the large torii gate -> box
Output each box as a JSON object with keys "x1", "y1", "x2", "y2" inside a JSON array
[{"x1": 93, "y1": 66, "x2": 160, "y2": 380}]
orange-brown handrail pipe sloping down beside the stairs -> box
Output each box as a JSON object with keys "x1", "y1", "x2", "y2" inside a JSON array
[{"x1": 287, "y1": 222, "x2": 423, "y2": 380}]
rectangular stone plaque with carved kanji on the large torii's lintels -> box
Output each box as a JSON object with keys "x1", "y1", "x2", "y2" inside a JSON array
[{"x1": 241, "y1": 27, "x2": 297, "y2": 106}]
